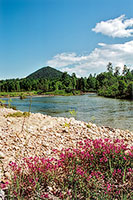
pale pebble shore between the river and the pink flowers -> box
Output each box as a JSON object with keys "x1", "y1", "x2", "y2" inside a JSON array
[{"x1": 0, "y1": 108, "x2": 133, "y2": 182}]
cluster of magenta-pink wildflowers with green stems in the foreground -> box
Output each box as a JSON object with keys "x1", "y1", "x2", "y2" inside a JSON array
[{"x1": 0, "y1": 139, "x2": 133, "y2": 200}]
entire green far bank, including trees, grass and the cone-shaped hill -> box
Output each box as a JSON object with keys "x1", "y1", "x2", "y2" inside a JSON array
[{"x1": 0, "y1": 63, "x2": 133, "y2": 99}]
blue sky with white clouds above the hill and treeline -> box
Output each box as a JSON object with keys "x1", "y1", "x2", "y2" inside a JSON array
[{"x1": 0, "y1": 0, "x2": 133, "y2": 79}]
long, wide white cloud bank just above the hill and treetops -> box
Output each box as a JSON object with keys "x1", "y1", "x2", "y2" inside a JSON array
[{"x1": 47, "y1": 40, "x2": 133, "y2": 77}]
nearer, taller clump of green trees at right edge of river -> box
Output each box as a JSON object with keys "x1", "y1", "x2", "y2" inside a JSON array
[{"x1": 96, "y1": 65, "x2": 133, "y2": 99}]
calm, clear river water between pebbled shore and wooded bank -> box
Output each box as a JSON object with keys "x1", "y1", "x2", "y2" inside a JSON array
[{"x1": 2, "y1": 93, "x2": 133, "y2": 130}]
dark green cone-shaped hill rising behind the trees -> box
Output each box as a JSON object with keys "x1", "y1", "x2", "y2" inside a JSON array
[{"x1": 26, "y1": 66, "x2": 63, "y2": 79}]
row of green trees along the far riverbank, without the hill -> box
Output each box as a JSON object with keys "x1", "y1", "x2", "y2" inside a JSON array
[{"x1": 0, "y1": 63, "x2": 133, "y2": 99}]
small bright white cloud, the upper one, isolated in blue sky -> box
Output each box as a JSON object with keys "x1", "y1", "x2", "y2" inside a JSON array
[{"x1": 92, "y1": 15, "x2": 133, "y2": 38}]
